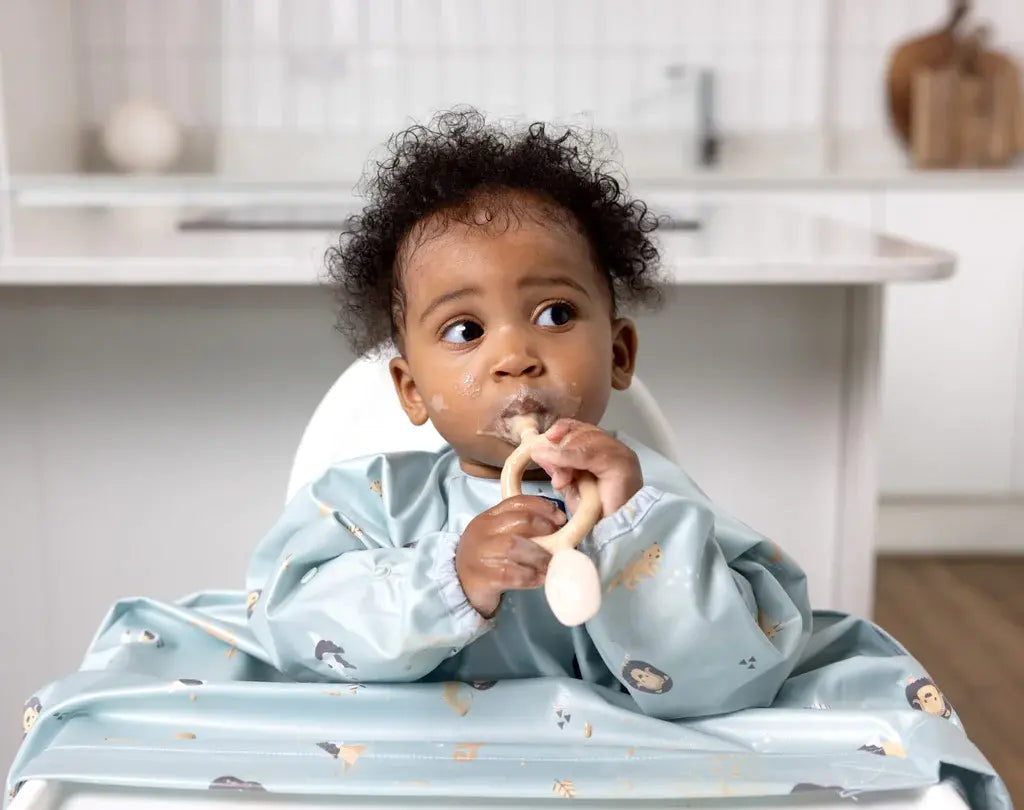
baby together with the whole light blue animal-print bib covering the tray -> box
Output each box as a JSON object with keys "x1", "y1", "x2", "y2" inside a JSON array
[{"x1": 6, "y1": 112, "x2": 1011, "y2": 810}]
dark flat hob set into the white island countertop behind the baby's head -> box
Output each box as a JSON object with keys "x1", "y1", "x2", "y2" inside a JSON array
[{"x1": 178, "y1": 206, "x2": 700, "y2": 231}]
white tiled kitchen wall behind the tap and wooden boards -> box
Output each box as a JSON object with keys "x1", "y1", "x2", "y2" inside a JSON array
[{"x1": 0, "y1": 0, "x2": 1024, "y2": 180}]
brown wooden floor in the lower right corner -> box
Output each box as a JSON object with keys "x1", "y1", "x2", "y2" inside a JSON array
[{"x1": 874, "y1": 557, "x2": 1024, "y2": 808}]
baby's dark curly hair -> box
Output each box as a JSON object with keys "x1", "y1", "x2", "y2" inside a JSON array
[{"x1": 326, "y1": 109, "x2": 658, "y2": 355}]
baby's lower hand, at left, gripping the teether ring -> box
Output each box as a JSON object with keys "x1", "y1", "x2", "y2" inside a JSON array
[{"x1": 455, "y1": 495, "x2": 565, "y2": 619}]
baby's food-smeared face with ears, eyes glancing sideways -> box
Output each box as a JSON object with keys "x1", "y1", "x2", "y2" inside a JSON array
[{"x1": 391, "y1": 193, "x2": 636, "y2": 477}]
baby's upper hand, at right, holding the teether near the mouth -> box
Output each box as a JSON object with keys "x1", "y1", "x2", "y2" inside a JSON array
[{"x1": 530, "y1": 419, "x2": 643, "y2": 517}]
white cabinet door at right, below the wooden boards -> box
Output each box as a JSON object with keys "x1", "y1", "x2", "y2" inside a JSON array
[{"x1": 881, "y1": 189, "x2": 1024, "y2": 495}]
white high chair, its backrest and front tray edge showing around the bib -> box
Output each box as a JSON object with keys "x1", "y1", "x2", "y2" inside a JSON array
[{"x1": 16, "y1": 360, "x2": 969, "y2": 810}]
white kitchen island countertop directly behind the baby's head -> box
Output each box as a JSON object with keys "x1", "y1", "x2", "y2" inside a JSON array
[{"x1": 0, "y1": 205, "x2": 955, "y2": 286}]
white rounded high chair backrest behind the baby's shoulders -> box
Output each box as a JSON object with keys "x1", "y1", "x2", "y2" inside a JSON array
[{"x1": 288, "y1": 357, "x2": 679, "y2": 500}]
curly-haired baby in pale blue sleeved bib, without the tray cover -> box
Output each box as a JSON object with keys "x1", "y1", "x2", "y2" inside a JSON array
[{"x1": 247, "y1": 111, "x2": 811, "y2": 719}]
